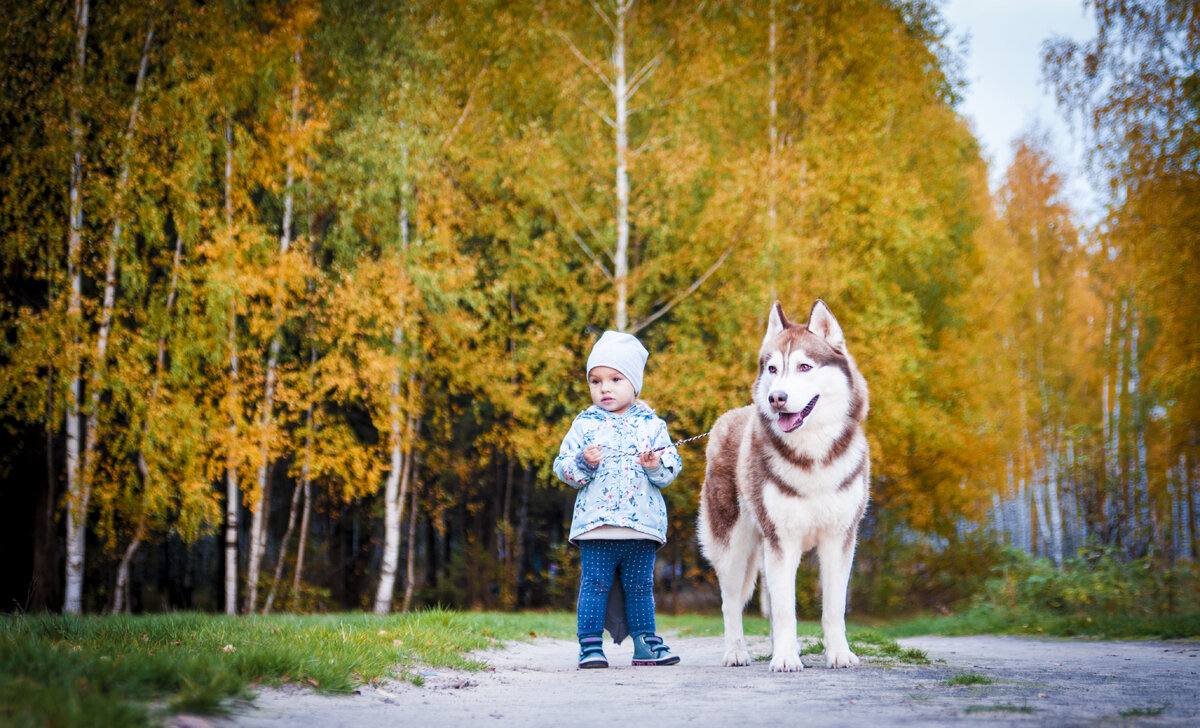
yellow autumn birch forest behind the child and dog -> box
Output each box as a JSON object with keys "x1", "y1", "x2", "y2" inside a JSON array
[{"x1": 0, "y1": 0, "x2": 1200, "y2": 614}]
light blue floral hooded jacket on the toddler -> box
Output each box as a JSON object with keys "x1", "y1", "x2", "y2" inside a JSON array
[{"x1": 554, "y1": 399, "x2": 683, "y2": 543}]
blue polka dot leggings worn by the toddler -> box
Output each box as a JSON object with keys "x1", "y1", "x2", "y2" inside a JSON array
[{"x1": 576, "y1": 539, "x2": 659, "y2": 639}]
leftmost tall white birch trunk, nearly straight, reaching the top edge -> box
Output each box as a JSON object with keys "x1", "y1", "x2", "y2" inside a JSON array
[{"x1": 62, "y1": 0, "x2": 89, "y2": 614}]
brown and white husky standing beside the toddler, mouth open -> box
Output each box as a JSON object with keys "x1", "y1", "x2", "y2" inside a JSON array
[{"x1": 697, "y1": 301, "x2": 870, "y2": 672}]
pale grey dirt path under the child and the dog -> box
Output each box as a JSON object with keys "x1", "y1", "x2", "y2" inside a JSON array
[{"x1": 212, "y1": 636, "x2": 1200, "y2": 728}]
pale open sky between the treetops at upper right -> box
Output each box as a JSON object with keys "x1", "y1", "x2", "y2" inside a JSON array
[{"x1": 942, "y1": 0, "x2": 1098, "y2": 222}]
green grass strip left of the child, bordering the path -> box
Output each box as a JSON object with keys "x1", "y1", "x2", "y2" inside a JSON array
[{"x1": 0, "y1": 609, "x2": 561, "y2": 727}]
